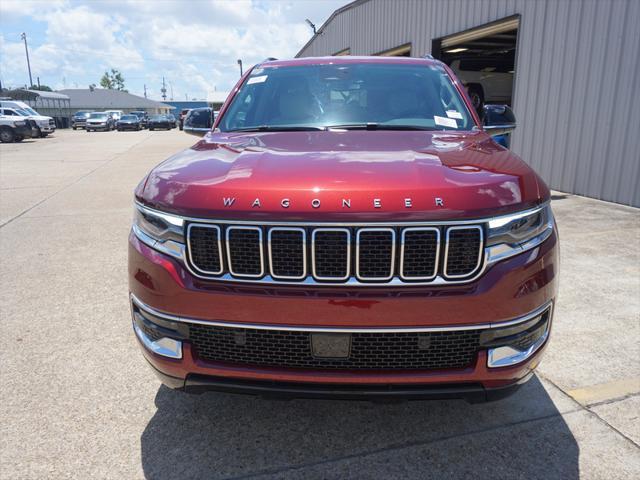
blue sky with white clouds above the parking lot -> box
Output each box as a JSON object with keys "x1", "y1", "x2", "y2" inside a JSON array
[{"x1": 0, "y1": 0, "x2": 349, "y2": 101}]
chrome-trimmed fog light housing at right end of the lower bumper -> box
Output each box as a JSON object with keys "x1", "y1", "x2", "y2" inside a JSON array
[{"x1": 481, "y1": 306, "x2": 551, "y2": 368}]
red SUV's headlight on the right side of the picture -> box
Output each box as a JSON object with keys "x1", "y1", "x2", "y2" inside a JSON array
[{"x1": 487, "y1": 204, "x2": 553, "y2": 263}]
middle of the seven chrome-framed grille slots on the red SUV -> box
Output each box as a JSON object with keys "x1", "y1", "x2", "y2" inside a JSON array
[{"x1": 311, "y1": 228, "x2": 351, "y2": 280}]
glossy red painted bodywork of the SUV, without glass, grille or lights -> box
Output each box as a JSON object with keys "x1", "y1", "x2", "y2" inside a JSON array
[{"x1": 129, "y1": 57, "x2": 559, "y2": 402}]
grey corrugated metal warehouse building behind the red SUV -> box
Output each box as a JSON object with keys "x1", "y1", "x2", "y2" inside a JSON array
[{"x1": 297, "y1": 0, "x2": 640, "y2": 206}]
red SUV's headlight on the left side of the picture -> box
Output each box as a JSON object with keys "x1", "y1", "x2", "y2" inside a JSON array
[{"x1": 132, "y1": 205, "x2": 185, "y2": 258}]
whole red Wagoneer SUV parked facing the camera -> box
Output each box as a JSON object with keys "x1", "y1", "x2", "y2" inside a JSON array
[{"x1": 129, "y1": 57, "x2": 558, "y2": 401}]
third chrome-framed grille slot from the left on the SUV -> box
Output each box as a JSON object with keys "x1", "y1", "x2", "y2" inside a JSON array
[{"x1": 269, "y1": 227, "x2": 307, "y2": 280}]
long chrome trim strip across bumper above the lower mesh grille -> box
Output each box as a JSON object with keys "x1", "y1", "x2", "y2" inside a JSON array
[{"x1": 129, "y1": 293, "x2": 553, "y2": 333}]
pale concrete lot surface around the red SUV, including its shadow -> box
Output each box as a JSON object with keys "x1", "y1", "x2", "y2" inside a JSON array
[{"x1": 0, "y1": 130, "x2": 640, "y2": 479}]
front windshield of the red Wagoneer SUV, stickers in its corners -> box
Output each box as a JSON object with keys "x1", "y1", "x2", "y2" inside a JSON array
[{"x1": 218, "y1": 63, "x2": 474, "y2": 131}]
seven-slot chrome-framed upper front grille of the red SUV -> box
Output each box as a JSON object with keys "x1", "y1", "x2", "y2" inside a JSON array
[{"x1": 186, "y1": 223, "x2": 484, "y2": 285}]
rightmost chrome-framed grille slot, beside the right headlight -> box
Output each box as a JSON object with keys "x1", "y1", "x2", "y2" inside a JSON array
[{"x1": 444, "y1": 226, "x2": 483, "y2": 278}]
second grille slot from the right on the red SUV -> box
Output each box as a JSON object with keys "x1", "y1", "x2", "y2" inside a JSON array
[{"x1": 400, "y1": 227, "x2": 440, "y2": 280}]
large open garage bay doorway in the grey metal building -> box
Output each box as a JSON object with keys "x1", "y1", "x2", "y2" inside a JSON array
[{"x1": 432, "y1": 15, "x2": 520, "y2": 113}]
